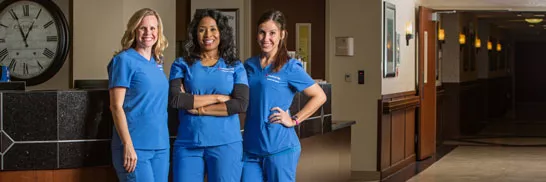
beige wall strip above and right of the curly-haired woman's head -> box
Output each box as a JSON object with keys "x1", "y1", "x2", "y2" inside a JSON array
[{"x1": 191, "y1": 0, "x2": 255, "y2": 60}]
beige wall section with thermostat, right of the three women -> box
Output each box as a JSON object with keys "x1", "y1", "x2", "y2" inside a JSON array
[{"x1": 326, "y1": 0, "x2": 382, "y2": 171}]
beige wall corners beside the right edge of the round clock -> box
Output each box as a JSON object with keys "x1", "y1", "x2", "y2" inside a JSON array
[{"x1": 27, "y1": 0, "x2": 70, "y2": 90}]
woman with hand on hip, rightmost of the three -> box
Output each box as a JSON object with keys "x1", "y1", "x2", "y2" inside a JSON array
[{"x1": 242, "y1": 10, "x2": 326, "y2": 182}]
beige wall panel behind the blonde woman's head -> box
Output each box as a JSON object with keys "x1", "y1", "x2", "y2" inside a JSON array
[{"x1": 73, "y1": 0, "x2": 176, "y2": 80}]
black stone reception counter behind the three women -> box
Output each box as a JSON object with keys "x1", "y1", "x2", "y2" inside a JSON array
[{"x1": 0, "y1": 84, "x2": 344, "y2": 170}]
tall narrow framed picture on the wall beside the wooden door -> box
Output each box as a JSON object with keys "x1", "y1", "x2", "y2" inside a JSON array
[{"x1": 383, "y1": 1, "x2": 396, "y2": 77}]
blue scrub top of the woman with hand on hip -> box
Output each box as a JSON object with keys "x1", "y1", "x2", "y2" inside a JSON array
[{"x1": 243, "y1": 56, "x2": 315, "y2": 156}]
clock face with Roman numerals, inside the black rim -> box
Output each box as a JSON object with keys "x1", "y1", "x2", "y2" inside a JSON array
[{"x1": 0, "y1": 1, "x2": 59, "y2": 79}]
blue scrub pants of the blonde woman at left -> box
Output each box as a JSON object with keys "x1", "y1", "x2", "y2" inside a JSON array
[{"x1": 112, "y1": 148, "x2": 170, "y2": 182}]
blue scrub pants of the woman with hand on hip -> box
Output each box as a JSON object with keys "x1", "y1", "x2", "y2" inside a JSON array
[{"x1": 242, "y1": 146, "x2": 301, "y2": 182}]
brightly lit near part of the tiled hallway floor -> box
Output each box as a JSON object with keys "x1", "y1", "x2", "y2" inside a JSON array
[{"x1": 408, "y1": 146, "x2": 546, "y2": 182}]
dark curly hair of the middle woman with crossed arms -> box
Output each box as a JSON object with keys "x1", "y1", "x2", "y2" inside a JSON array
[{"x1": 183, "y1": 9, "x2": 239, "y2": 65}]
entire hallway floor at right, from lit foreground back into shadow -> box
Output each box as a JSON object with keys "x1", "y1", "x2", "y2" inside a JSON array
[{"x1": 408, "y1": 120, "x2": 546, "y2": 182}]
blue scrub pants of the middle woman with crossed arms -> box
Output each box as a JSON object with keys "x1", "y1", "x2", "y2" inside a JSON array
[{"x1": 173, "y1": 142, "x2": 243, "y2": 182}]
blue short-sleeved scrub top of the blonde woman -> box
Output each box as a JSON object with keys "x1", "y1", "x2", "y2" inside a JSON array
[{"x1": 108, "y1": 48, "x2": 170, "y2": 149}]
